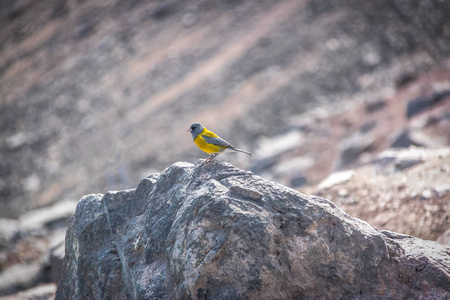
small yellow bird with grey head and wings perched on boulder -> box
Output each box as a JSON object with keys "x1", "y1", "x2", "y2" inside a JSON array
[{"x1": 187, "y1": 123, "x2": 253, "y2": 164}]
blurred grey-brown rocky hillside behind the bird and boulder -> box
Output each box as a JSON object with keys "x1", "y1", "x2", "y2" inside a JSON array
[{"x1": 0, "y1": 0, "x2": 450, "y2": 294}]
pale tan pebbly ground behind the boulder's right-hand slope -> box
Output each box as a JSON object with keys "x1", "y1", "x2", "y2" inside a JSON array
[{"x1": 314, "y1": 147, "x2": 450, "y2": 244}]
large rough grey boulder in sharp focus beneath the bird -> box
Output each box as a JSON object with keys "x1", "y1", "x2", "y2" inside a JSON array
[{"x1": 56, "y1": 161, "x2": 450, "y2": 299}]
